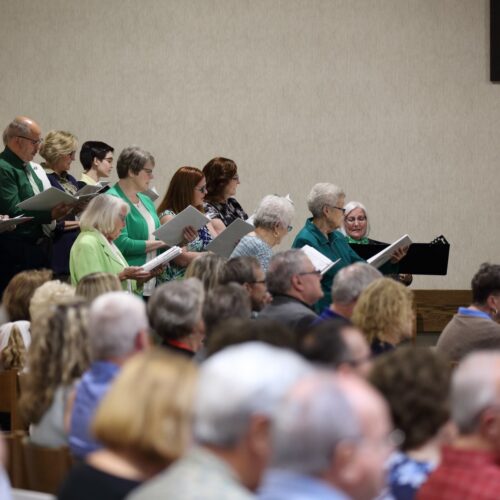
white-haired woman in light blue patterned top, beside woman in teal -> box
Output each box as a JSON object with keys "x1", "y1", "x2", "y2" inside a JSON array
[{"x1": 231, "y1": 195, "x2": 295, "y2": 272}]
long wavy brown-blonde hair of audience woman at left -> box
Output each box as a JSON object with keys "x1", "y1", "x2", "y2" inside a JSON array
[{"x1": 19, "y1": 297, "x2": 90, "y2": 424}]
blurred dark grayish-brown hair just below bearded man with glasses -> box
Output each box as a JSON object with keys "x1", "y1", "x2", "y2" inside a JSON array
[{"x1": 203, "y1": 283, "x2": 252, "y2": 335}]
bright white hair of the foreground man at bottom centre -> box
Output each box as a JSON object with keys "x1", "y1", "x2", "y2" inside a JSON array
[{"x1": 193, "y1": 342, "x2": 312, "y2": 448}]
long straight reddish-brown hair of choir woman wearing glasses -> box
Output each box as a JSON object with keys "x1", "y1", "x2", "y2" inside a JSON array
[{"x1": 157, "y1": 167, "x2": 204, "y2": 214}]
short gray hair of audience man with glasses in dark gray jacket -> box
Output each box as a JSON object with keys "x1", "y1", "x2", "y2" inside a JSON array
[{"x1": 266, "y1": 249, "x2": 309, "y2": 295}]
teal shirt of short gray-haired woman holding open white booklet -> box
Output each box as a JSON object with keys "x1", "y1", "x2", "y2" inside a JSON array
[{"x1": 292, "y1": 218, "x2": 366, "y2": 312}]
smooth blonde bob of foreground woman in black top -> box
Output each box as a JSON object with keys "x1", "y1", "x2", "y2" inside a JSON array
[{"x1": 92, "y1": 348, "x2": 197, "y2": 468}]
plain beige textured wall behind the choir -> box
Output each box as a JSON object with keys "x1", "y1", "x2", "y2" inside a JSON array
[{"x1": 0, "y1": 0, "x2": 500, "y2": 288}]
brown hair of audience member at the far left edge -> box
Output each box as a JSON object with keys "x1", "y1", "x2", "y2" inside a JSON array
[{"x1": 2, "y1": 269, "x2": 52, "y2": 321}]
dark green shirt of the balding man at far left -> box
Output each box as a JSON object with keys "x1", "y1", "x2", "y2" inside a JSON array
[{"x1": 0, "y1": 147, "x2": 52, "y2": 241}]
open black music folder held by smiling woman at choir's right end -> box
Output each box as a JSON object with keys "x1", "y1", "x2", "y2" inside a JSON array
[{"x1": 350, "y1": 235, "x2": 450, "y2": 276}]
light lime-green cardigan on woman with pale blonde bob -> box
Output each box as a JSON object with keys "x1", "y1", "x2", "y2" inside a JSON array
[{"x1": 69, "y1": 229, "x2": 135, "y2": 290}]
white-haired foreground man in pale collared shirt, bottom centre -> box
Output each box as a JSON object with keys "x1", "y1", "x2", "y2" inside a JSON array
[{"x1": 130, "y1": 342, "x2": 310, "y2": 500}]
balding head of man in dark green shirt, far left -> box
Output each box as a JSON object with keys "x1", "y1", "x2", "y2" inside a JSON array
[{"x1": 3, "y1": 116, "x2": 42, "y2": 162}]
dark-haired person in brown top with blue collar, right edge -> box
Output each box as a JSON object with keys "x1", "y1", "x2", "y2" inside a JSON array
[{"x1": 436, "y1": 263, "x2": 500, "y2": 361}]
